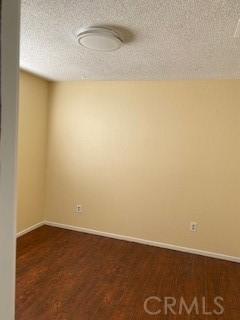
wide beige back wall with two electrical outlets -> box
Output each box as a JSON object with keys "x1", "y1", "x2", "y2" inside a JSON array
[{"x1": 45, "y1": 81, "x2": 240, "y2": 256}]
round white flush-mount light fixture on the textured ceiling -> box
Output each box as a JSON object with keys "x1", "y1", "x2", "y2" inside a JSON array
[{"x1": 77, "y1": 27, "x2": 123, "y2": 51}]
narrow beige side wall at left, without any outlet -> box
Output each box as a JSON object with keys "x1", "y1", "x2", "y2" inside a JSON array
[{"x1": 17, "y1": 72, "x2": 48, "y2": 231}]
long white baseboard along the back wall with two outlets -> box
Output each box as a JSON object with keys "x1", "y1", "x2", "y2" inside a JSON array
[{"x1": 44, "y1": 221, "x2": 240, "y2": 263}]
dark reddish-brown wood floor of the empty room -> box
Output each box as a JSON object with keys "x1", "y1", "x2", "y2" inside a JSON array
[{"x1": 16, "y1": 226, "x2": 240, "y2": 320}]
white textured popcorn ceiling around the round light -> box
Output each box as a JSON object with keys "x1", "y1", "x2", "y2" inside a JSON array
[{"x1": 20, "y1": 0, "x2": 240, "y2": 80}]
